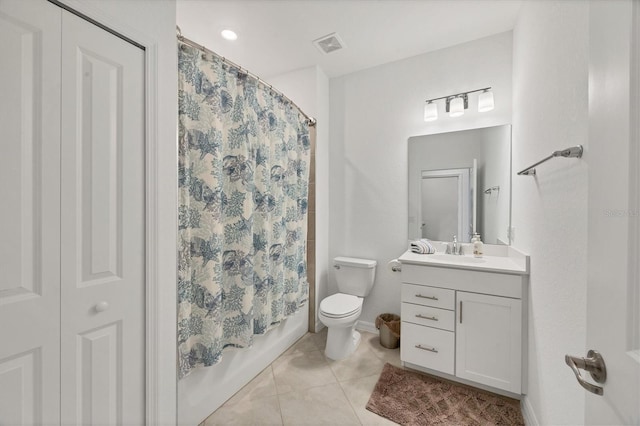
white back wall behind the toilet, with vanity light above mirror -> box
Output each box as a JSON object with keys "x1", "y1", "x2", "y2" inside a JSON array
[{"x1": 329, "y1": 32, "x2": 512, "y2": 324}]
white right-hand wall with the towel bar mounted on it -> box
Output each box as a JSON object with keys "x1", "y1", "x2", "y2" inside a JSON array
[{"x1": 512, "y1": 1, "x2": 588, "y2": 424}]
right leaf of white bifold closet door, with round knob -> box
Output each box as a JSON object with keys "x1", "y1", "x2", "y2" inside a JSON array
[{"x1": 60, "y1": 11, "x2": 145, "y2": 425}]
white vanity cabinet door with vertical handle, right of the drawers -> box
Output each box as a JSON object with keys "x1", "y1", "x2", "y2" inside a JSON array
[{"x1": 456, "y1": 291, "x2": 522, "y2": 394}]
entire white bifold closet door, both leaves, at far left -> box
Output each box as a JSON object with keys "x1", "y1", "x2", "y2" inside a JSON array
[{"x1": 0, "y1": 0, "x2": 145, "y2": 425}]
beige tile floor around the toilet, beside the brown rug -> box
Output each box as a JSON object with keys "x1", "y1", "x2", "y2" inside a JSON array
[{"x1": 202, "y1": 328, "x2": 401, "y2": 426}]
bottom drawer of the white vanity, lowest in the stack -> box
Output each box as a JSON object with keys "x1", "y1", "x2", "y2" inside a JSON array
[{"x1": 400, "y1": 321, "x2": 455, "y2": 375}]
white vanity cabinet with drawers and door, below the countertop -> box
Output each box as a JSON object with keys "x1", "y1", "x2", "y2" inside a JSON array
[{"x1": 400, "y1": 258, "x2": 528, "y2": 395}]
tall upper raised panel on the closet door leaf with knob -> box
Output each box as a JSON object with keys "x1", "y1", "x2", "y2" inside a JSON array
[{"x1": 76, "y1": 47, "x2": 123, "y2": 287}]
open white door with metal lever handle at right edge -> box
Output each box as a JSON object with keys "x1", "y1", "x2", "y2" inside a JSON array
[{"x1": 584, "y1": 0, "x2": 640, "y2": 424}]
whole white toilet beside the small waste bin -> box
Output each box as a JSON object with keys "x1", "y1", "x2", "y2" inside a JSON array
[{"x1": 318, "y1": 257, "x2": 377, "y2": 360}]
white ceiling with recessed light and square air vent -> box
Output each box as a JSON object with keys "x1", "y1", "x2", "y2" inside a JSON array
[{"x1": 177, "y1": 0, "x2": 523, "y2": 79}]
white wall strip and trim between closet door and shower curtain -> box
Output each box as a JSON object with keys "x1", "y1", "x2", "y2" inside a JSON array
[{"x1": 61, "y1": 0, "x2": 178, "y2": 425}]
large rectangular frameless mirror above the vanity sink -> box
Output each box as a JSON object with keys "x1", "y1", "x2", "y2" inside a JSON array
[{"x1": 408, "y1": 125, "x2": 511, "y2": 245}]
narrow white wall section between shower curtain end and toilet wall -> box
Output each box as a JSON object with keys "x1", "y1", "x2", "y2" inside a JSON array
[{"x1": 267, "y1": 66, "x2": 329, "y2": 331}]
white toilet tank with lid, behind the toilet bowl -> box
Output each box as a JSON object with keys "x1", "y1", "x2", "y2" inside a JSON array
[{"x1": 333, "y1": 257, "x2": 377, "y2": 297}]
